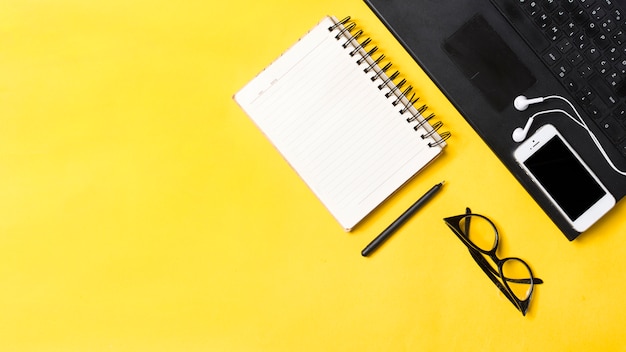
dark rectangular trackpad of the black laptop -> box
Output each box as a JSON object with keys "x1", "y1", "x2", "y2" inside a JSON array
[{"x1": 443, "y1": 15, "x2": 536, "y2": 111}]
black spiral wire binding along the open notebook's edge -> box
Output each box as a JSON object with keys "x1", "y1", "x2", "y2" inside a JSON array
[{"x1": 328, "y1": 16, "x2": 452, "y2": 147}]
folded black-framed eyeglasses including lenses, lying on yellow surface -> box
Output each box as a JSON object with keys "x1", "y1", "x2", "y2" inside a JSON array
[{"x1": 443, "y1": 208, "x2": 543, "y2": 315}]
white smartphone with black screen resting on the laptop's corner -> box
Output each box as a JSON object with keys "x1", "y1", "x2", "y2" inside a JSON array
[{"x1": 514, "y1": 124, "x2": 615, "y2": 232}]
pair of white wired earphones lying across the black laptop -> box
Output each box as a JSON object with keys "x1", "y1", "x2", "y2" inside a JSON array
[{"x1": 512, "y1": 95, "x2": 626, "y2": 176}]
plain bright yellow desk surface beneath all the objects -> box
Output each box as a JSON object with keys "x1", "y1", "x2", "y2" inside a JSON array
[{"x1": 0, "y1": 0, "x2": 626, "y2": 352}]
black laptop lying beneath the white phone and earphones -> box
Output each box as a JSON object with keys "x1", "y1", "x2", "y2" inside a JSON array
[{"x1": 365, "y1": 0, "x2": 626, "y2": 240}]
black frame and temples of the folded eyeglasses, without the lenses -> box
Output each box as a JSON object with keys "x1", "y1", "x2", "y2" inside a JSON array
[{"x1": 443, "y1": 208, "x2": 543, "y2": 316}]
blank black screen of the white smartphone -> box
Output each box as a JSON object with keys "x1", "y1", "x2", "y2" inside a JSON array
[{"x1": 524, "y1": 137, "x2": 606, "y2": 220}]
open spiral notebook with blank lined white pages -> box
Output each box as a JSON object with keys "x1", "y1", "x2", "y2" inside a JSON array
[{"x1": 234, "y1": 17, "x2": 450, "y2": 231}]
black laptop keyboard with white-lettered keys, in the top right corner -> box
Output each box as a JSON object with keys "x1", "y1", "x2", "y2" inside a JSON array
[{"x1": 493, "y1": 0, "x2": 626, "y2": 157}]
